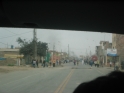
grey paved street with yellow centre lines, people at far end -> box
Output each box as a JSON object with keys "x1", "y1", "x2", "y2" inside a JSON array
[{"x1": 0, "y1": 62, "x2": 113, "y2": 93}]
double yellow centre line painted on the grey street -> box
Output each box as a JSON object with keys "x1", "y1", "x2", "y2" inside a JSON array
[{"x1": 54, "y1": 69, "x2": 74, "y2": 93}]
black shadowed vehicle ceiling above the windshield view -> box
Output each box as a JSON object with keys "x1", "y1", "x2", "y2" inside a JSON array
[{"x1": 0, "y1": 0, "x2": 124, "y2": 93}]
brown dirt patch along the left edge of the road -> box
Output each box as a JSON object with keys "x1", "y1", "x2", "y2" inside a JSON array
[{"x1": 0, "y1": 66, "x2": 32, "y2": 73}]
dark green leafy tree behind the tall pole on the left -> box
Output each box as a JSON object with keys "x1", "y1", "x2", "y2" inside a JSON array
[{"x1": 17, "y1": 37, "x2": 48, "y2": 63}]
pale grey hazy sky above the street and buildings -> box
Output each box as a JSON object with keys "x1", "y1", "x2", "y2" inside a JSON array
[{"x1": 0, "y1": 28, "x2": 112, "y2": 56}]
